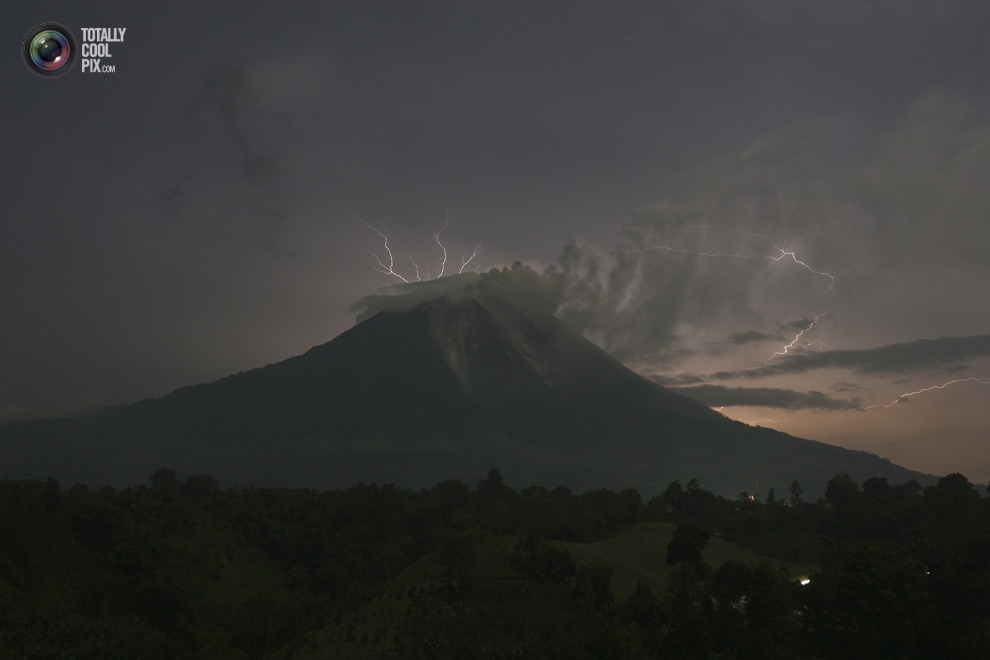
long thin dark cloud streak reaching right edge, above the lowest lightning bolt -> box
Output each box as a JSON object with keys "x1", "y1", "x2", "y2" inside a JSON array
[{"x1": 712, "y1": 335, "x2": 990, "y2": 380}]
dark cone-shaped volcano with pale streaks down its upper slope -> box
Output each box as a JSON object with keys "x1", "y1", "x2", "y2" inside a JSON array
[{"x1": 0, "y1": 282, "x2": 927, "y2": 495}]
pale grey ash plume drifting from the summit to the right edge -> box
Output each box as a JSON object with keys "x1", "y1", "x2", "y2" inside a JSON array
[{"x1": 553, "y1": 91, "x2": 990, "y2": 368}]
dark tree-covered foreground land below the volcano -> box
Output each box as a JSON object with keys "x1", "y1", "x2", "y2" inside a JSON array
[{"x1": 0, "y1": 469, "x2": 990, "y2": 660}]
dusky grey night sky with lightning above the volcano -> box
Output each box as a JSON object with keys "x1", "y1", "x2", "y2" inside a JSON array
[{"x1": 0, "y1": 0, "x2": 990, "y2": 483}]
